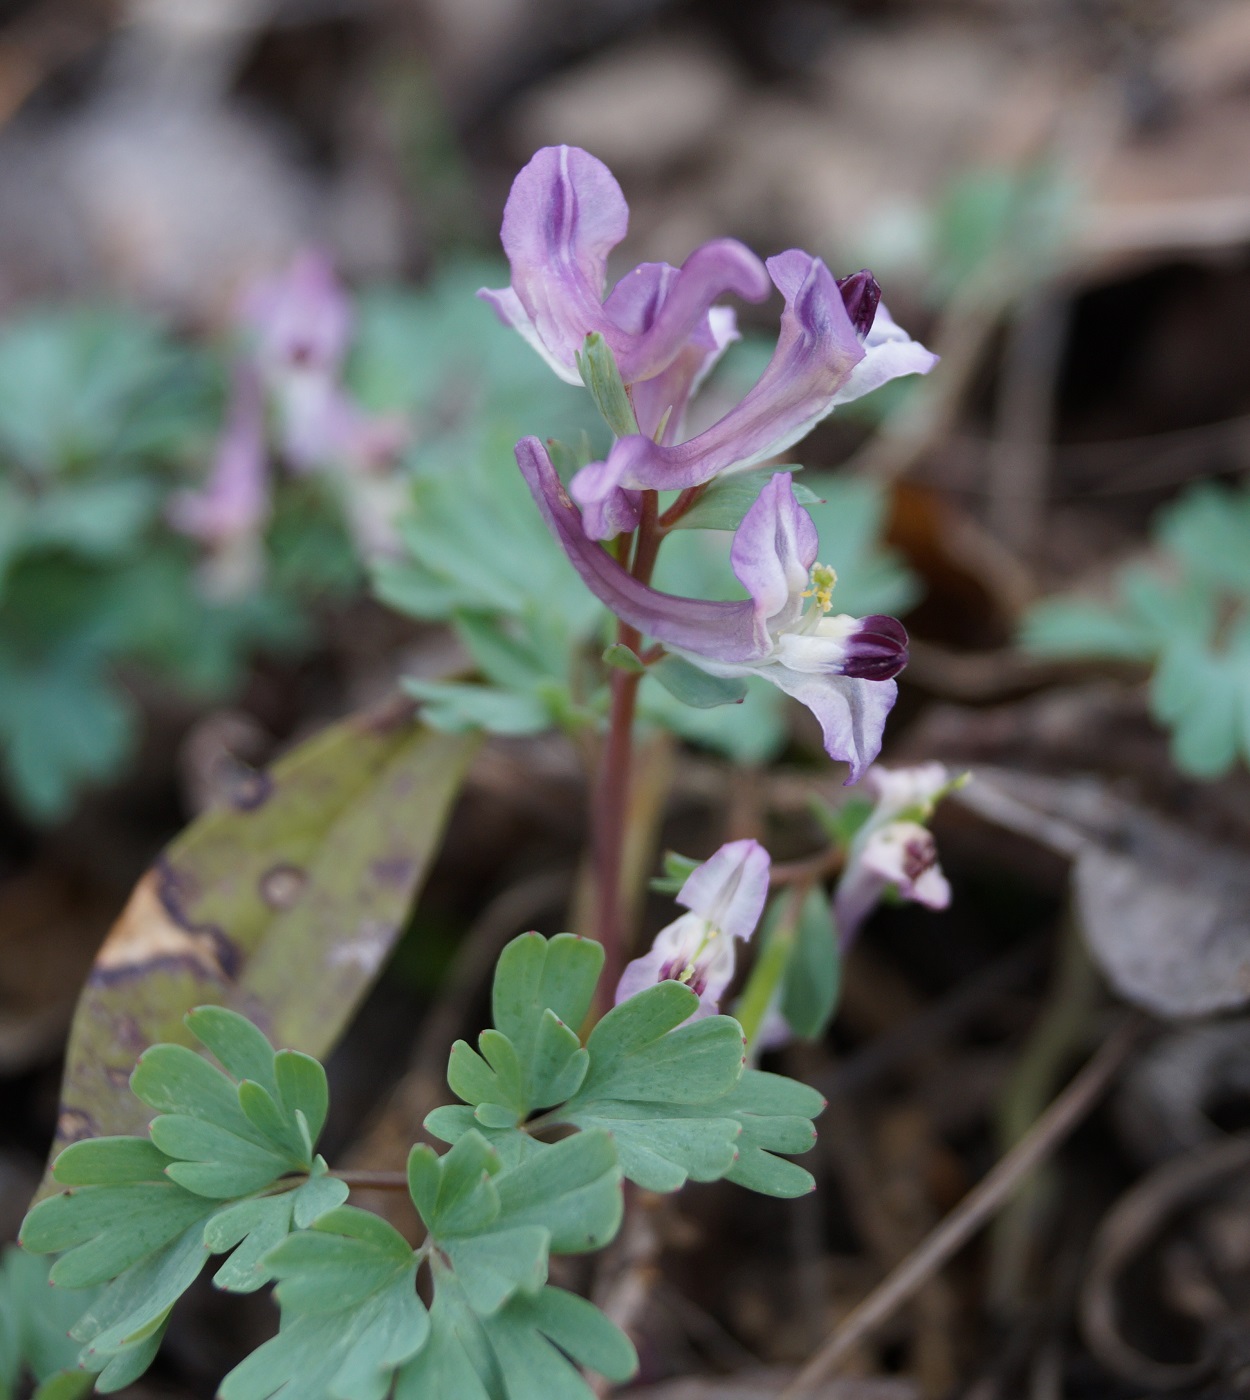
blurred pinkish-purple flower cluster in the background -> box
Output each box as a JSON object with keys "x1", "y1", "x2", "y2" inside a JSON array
[{"x1": 169, "y1": 252, "x2": 406, "y2": 592}]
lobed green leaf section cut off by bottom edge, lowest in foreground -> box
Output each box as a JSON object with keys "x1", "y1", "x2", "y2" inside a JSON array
[{"x1": 220, "y1": 1130, "x2": 637, "y2": 1400}]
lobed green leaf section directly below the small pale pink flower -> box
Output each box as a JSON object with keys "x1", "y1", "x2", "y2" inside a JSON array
[{"x1": 426, "y1": 934, "x2": 822, "y2": 1196}]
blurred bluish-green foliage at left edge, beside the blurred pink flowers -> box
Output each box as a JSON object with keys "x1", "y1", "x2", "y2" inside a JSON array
[{"x1": 0, "y1": 299, "x2": 331, "y2": 820}]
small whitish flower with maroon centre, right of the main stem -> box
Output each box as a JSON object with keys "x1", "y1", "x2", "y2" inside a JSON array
[{"x1": 833, "y1": 763, "x2": 952, "y2": 948}]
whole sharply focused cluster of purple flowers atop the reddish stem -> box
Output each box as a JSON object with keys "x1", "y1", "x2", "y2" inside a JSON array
[{"x1": 480, "y1": 146, "x2": 935, "y2": 781}]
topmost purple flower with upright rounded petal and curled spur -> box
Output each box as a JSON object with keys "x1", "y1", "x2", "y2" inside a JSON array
[{"x1": 479, "y1": 146, "x2": 768, "y2": 396}]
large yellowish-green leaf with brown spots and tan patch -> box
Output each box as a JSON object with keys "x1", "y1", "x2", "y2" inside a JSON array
[{"x1": 39, "y1": 711, "x2": 475, "y2": 1191}]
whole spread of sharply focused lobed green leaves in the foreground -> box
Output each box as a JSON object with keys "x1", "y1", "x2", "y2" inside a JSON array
[{"x1": 24, "y1": 934, "x2": 823, "y2": 1400}]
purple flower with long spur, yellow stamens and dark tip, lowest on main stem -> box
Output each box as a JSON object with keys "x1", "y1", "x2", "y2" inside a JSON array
[{"x1": 517, "y1": 438, "x2": 907, "y2": 783}]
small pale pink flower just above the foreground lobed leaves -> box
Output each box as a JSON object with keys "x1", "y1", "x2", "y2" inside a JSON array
[{"x1": 616, "y1": 841, "x2": 770, "y2": 1021}]
